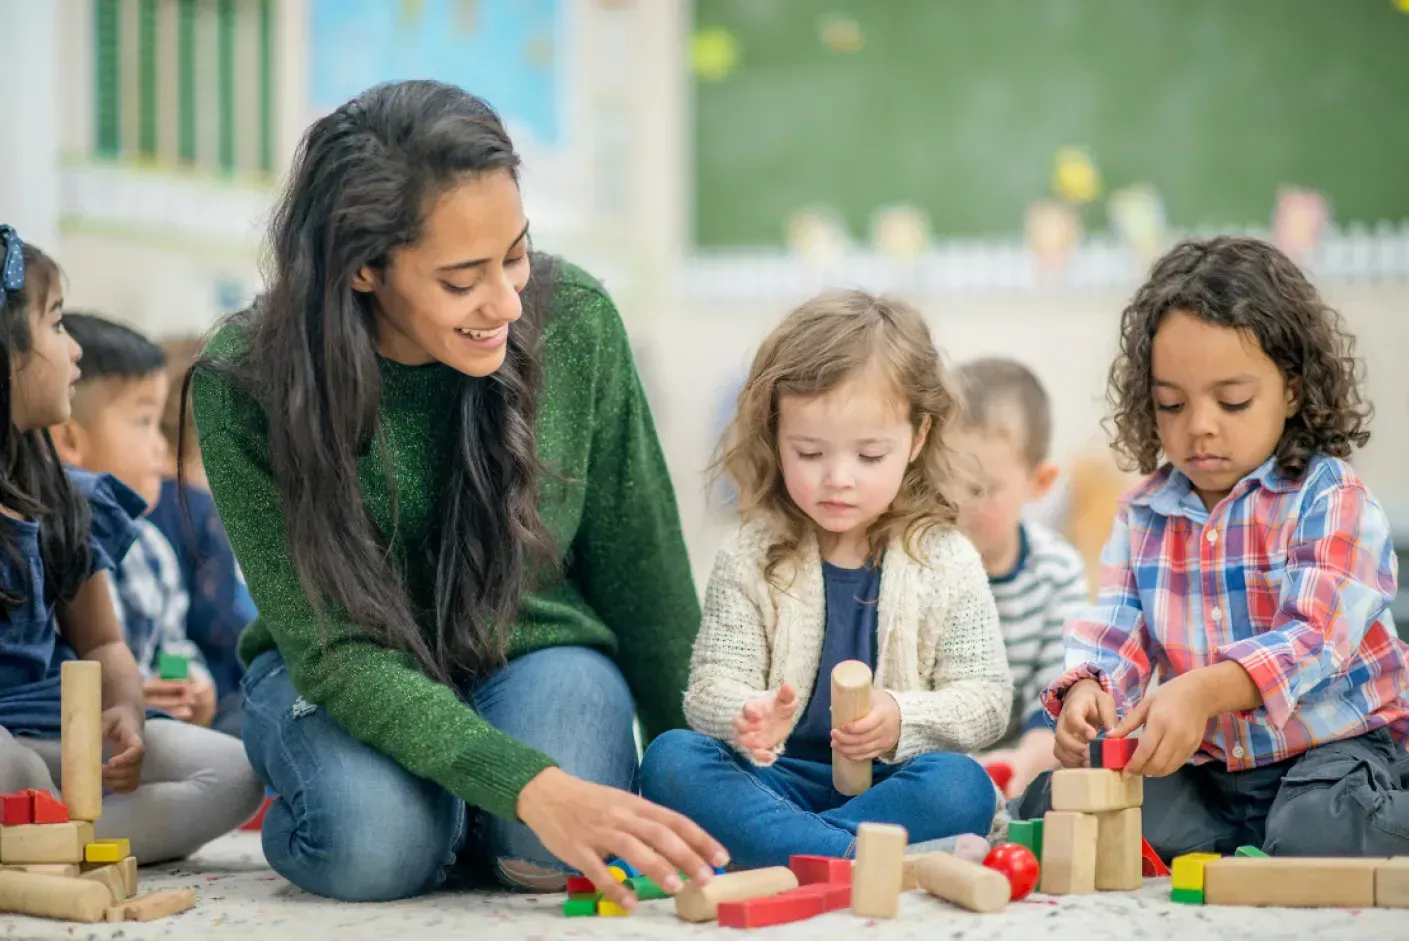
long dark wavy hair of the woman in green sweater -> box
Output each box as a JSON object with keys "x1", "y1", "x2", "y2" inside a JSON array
[{"x1": 180, "y1": 82, "x2": 557, "y2": 682}]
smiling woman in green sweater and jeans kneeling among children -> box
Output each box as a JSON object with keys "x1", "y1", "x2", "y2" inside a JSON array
[{"x1": 192, "y1": 82, "x2": 724, "y2": 907}]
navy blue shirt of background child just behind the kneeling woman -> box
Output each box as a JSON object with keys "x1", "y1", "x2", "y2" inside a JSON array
[{"x1": 147, "y1": 479, "x2": 256, "y2": 697}]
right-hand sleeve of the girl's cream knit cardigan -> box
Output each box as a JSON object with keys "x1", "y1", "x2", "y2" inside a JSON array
[{"x1": 886, "y1": 531, "x2": 1013, "y2": 762}]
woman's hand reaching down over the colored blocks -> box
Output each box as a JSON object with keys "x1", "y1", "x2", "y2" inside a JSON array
[{"x1": 517, "y1": 768, "x2": 728, "y2": 911}]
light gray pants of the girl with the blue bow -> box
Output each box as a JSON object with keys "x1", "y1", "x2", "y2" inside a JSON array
[{"x1": 0, "y1": 718, "x2": 263, "y2": 865}]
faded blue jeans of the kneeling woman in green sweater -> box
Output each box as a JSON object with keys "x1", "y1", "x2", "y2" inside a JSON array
[{"x1": 244, "y1": 647, "x2": 637, "y2": 902}]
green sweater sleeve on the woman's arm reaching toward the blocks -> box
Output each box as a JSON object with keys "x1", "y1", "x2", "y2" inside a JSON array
[{"x1": 194, "y1": 356, "x2": 554, "y2": 820}]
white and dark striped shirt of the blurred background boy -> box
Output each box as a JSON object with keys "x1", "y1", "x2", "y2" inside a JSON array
[{"x1": 988, "y1": 523, "x2": 1091, "y2": 744}]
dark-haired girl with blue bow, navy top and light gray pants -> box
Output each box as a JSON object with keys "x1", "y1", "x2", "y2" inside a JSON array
[{"x1": 0, "y1": 225, "x2": 261, "y2": 864}]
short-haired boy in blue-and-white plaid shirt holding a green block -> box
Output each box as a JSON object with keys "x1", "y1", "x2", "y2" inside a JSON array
[{"x1": 51, "y1": 313, "x2": 216, "y2": 725}]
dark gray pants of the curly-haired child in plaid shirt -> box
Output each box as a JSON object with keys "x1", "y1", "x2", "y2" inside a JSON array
[{"x1": 1009, "y1": 728, "x2": 1409, "y2": 862}]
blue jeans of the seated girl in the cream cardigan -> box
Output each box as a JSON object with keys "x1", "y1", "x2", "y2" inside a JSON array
[{"x1": 641, "y1": 730, "x2": 998, "y2": 868}]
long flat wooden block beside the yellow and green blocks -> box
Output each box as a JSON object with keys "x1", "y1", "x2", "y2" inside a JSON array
[{"x1": 1203, "y1": 856, "x2": 1385, "y2": 909}]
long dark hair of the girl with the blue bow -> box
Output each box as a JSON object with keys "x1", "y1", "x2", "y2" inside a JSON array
[{"x1": 0, "y1": 245, "x2": 92, "y2": 611}]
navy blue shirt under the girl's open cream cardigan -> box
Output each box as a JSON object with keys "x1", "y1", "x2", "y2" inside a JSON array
[{"x1": 785, "y1": 562, "x2": 881, "y2": 765}]
